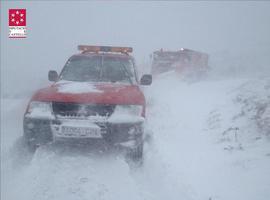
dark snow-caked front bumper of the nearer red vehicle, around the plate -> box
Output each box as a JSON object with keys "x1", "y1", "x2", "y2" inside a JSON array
[{"x1": 23, "y1": 117, "x2": 144, "y2": 148}]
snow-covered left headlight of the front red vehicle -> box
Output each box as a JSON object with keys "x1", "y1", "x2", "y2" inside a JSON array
[{"x1": 27, "y1": 101, "x2": 53, "y2": 118}]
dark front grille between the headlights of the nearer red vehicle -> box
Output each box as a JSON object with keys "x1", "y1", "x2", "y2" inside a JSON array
[{"x1": 52, "y1": 102, "x2": 115, "y2": 117}]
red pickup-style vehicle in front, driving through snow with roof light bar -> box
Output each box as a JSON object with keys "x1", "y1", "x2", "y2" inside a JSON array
[{"x1": 23, "y1": 45, "x2": 152, "y2": 159}]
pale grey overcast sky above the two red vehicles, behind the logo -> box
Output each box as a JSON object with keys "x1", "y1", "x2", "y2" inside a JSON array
[{"x1": 0, "y1": 1, "x2": 270, "y2": 94}]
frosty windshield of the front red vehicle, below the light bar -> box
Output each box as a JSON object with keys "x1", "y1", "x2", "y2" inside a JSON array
[{"x1": 60, "y1": 55, "x2": 136, "y2": 84}]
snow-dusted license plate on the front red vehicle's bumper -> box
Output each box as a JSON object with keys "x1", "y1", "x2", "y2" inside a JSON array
[{"x1": 59, "y1": 126, "x2": 102, "y2": 138}]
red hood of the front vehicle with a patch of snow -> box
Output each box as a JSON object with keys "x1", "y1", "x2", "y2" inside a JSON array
[{"x1": 32, "y1": 81, "x2": 145, "y2": 105}]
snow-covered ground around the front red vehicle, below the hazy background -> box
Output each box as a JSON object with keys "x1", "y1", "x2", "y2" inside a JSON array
[{"x1": 1, "y1": 74, "x2": 270, "y2": 200}]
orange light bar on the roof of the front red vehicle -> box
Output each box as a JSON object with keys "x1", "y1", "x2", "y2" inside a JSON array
[{"x1": 78, "y1": 45, "x2": 133, "y2": 53}]
